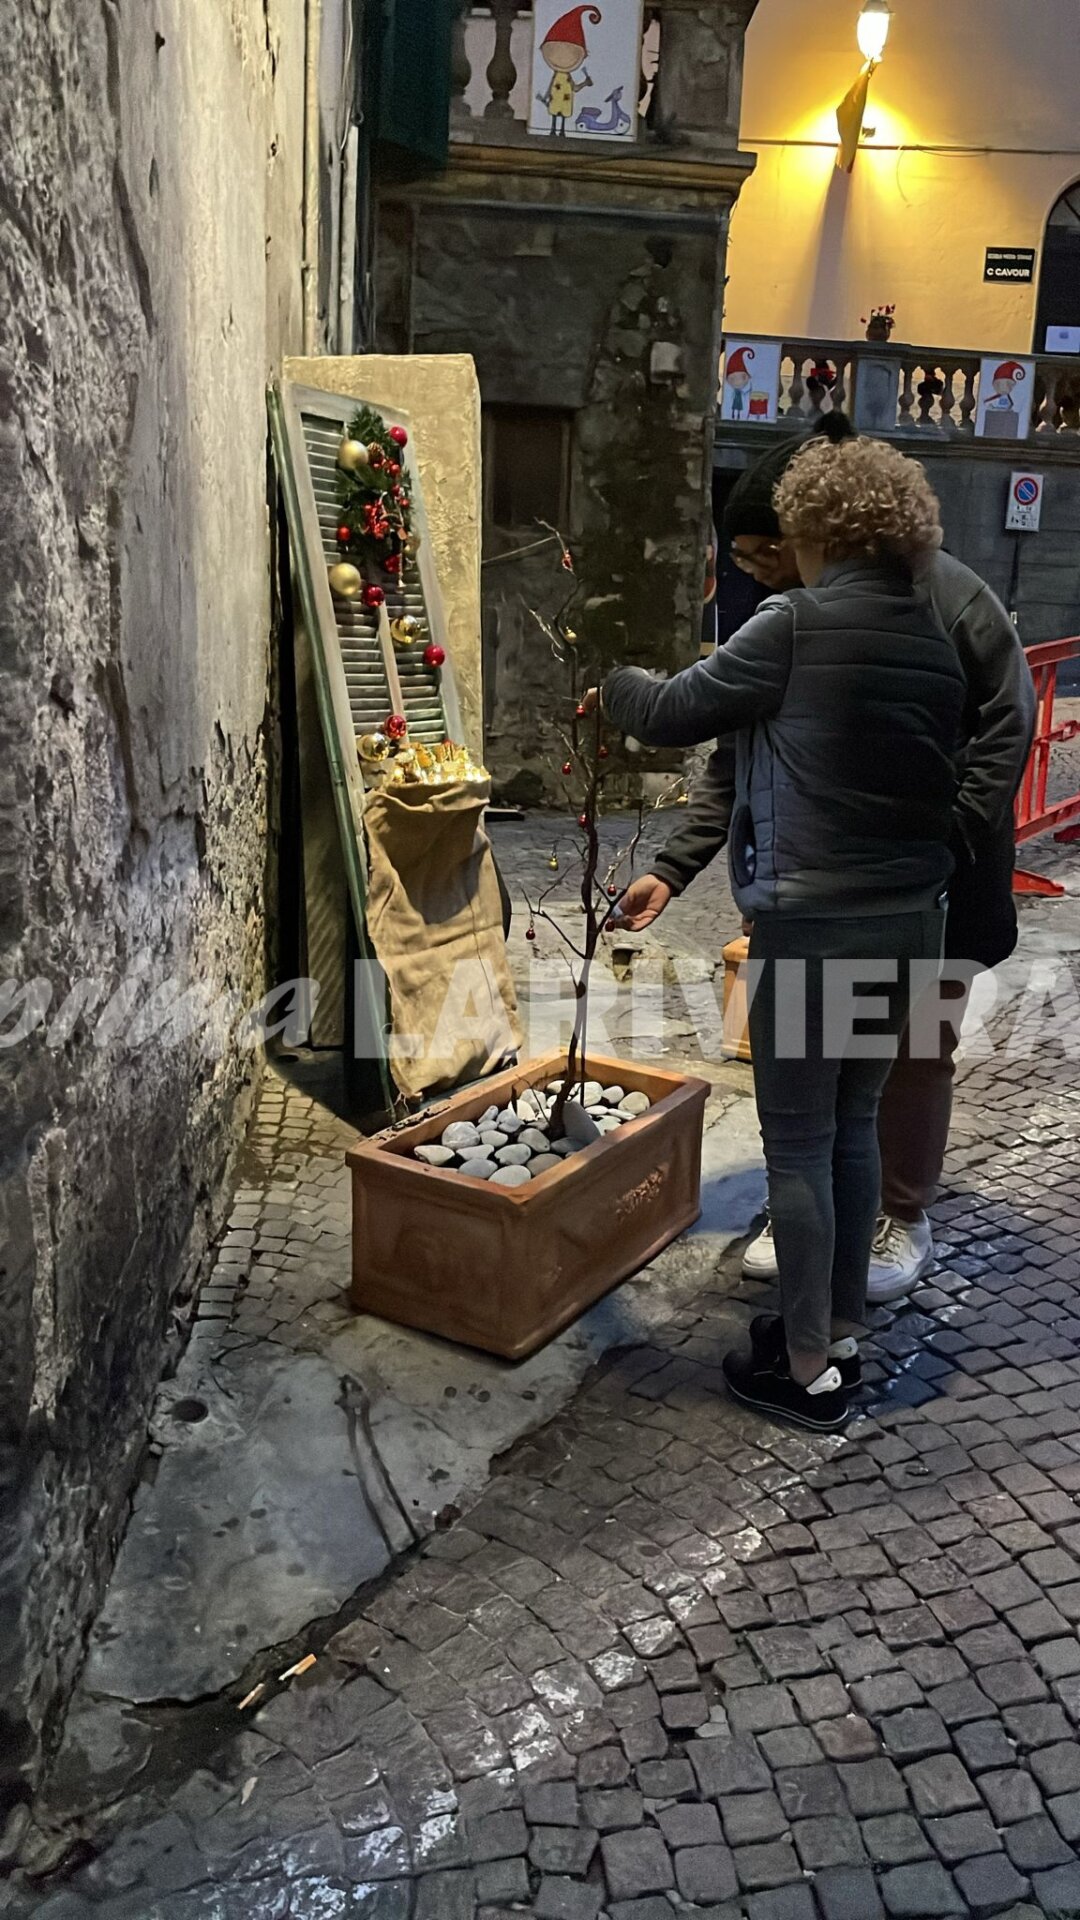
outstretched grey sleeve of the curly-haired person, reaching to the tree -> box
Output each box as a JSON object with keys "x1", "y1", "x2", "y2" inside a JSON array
[{"x1": 603, "y1": 597, "x2": 794, "y2": 747}]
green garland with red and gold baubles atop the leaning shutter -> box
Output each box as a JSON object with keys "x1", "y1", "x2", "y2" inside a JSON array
[{"x1": 338, "y1": 407, "x2": 421, "y2": 576}]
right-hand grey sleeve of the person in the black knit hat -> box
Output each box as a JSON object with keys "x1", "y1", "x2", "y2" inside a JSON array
[{"x1": 951, "y1": 586, "x2": 1036, "y2": 851}]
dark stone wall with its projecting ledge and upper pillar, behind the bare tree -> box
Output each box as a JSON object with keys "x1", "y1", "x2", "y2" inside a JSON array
[{"x1": 377, "y1": 0, "x2": 753, "y2": 804}]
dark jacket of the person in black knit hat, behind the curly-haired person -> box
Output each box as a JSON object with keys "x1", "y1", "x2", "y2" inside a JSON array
[{"x1": 630, "y1": 553, "x2": 1036, "y2": 966}]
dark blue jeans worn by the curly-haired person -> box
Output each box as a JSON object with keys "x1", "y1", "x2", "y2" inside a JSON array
[{"x1": 749, "y1": 912, "x2": 945, "y2": 1354}]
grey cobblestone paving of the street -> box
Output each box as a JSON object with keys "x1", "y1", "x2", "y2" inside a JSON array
[{"x1": 0, "y1": 828, "x2": 1080, "y2": 1920}]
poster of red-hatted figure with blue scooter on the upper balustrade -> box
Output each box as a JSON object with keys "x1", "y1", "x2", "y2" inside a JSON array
[{"x1": 528, "y1": 0, "x2": 644, "y2": 140}]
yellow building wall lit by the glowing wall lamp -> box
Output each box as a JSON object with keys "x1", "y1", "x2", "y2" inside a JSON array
[{"x1": 724, "y1": 0, "x2": 1080, "y2": 353}]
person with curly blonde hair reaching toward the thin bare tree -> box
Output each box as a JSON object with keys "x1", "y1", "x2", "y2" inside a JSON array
[{"x1": 601, "y1": 438, "x2": 967, "y2": 1432}]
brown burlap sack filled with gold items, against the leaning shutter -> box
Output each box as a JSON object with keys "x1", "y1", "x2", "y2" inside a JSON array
[{"x1": 363, "y1": 781, "x2": 521, "y2": 1098}]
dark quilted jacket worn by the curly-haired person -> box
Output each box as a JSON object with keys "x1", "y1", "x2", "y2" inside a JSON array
[{"x1": 603, "y1": 561, "x2": 967, "y2": 918}]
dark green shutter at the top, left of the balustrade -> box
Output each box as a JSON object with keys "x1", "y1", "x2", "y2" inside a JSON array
[{"x1": 371, "y1": 0, "x2": 455, "y2": 179}]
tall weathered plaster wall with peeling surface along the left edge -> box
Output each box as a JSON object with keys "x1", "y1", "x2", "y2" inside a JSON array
[{"x1": 0, "y1": 0, "x2": 304, "y2": 1807}]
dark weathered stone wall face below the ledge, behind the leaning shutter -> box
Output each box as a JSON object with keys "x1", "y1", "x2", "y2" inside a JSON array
[{"x1": 374, "y1": 207, "x2": 719, "y2": 801}]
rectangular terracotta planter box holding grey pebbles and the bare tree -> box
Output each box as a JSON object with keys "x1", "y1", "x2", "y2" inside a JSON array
[{"x1": 348, "y1": 1052, "x2": 709, "y2": 1359}]
